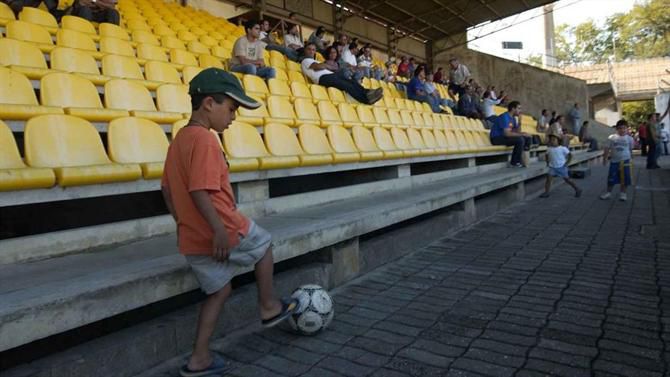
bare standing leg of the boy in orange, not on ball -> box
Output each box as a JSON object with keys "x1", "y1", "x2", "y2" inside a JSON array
[{"x1": 188, "y1": 283, "x2": 231, "y2": 370}]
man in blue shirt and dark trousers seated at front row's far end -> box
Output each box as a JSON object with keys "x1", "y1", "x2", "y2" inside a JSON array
[{"x1": 490, "y1": 101, "x2": 529, "y2": 168}]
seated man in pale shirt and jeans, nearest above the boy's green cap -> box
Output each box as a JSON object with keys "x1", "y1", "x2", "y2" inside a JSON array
[{"x1": 230, "y1": 20, "x2": 276, "y2": 79}]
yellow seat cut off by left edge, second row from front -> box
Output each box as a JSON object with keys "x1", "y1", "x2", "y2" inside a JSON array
[{"x1": 0, "y1": 67, "x2": 63, "y2": 120}]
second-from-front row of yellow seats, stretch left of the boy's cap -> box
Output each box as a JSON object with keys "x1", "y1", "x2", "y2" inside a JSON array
[{"x1": 0, "y1": 67, "x2": 191, "y2": 123}]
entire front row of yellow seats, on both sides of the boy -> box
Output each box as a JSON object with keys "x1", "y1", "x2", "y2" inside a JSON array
[{"x1": 0, "y1": 115, "x2": 504, "y2": 191}]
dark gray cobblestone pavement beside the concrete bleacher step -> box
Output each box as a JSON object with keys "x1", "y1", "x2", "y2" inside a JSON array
[{"x1": 147, "y1": 156, "x2": 670, "y2": 377}]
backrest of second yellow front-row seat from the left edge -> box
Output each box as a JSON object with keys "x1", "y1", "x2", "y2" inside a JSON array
[{"x1": 24, "y1": 115, "x2": 110, "y2": 168}]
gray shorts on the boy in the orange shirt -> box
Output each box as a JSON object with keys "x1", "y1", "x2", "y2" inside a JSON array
[{"x1": 186, "y1": 220, "x2": 272, "y2": 295}]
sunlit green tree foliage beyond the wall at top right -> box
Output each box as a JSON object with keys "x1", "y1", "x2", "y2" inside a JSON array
[{"x1": 554, "y1": 0, "x2": 670, "y2": 65}]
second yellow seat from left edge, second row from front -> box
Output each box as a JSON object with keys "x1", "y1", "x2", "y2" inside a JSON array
[{"x1": 40, "y1": 72, "x2": 128, "y2": 122}]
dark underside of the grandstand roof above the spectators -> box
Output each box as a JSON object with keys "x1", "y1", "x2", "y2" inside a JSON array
[{"x1": 342, "y1": 0, "x2": 555, "y2": 41}]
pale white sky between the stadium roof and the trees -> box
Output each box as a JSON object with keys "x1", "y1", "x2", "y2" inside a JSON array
[{"x1": 468, "y1": 0, "x2": 642, "y2": 61}]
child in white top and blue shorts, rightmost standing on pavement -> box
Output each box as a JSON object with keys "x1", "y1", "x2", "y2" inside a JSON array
[{"x1": 600, "y1": 119, "x2": 634, "y2": 201}]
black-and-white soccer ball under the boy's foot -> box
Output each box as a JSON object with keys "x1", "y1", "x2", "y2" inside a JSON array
[{"x1": 288, "y1": 284, "x2": 335, "y2": 335}]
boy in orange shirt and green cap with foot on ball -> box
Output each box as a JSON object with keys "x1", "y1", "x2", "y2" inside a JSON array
[{"x1": 161, "y1": 68, "x2": 297, "y2": 377}]
